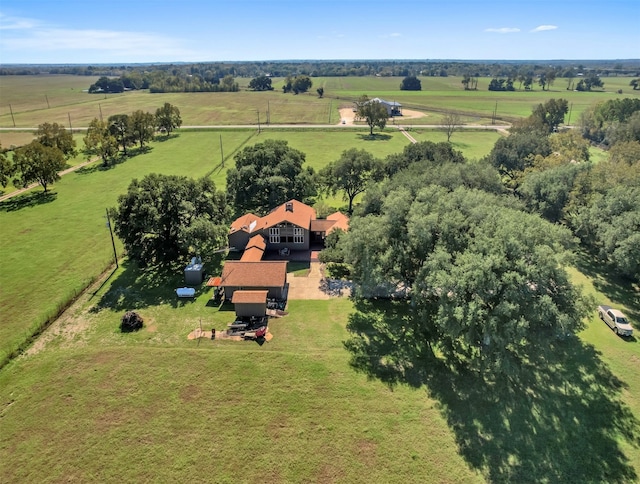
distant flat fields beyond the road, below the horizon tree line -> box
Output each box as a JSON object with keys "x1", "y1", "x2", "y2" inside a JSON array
[{"x1": 5, "y1": 76, "x2": 640, "y2": 128}]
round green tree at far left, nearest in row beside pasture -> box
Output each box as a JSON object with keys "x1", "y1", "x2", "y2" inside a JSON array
[{"x1": 13, "y1": 141, "x2": 67, "y2": 193}]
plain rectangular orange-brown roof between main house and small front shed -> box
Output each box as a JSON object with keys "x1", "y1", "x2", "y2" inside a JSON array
[{"x1": 221, "y1": 261, "x2": 287, "y2": 287}]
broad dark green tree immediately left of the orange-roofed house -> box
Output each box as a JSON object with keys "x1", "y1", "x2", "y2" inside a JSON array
[{"x1": 111, "y1": 173, "x2": 230, "y2": 265}]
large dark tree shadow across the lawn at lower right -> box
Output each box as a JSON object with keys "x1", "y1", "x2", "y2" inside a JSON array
[{"x1": 345, "y1": 302, "x2": 640, "y2": 483}]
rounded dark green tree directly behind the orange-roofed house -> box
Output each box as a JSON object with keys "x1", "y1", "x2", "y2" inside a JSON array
[{"x1": 227, "y1": 140, "x2": 317, "y2": 214}]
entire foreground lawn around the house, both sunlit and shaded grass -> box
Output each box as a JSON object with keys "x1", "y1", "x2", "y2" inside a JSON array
[{"x1": 0, "y1": 248, "x2": 640, "y2": 483}]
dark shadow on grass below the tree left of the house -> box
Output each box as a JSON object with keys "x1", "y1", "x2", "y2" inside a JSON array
[{"x1": 91, "y1": 260, "x2": 208, "y2": 312}]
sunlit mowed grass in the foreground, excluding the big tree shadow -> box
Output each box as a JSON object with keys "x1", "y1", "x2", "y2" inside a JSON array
[{"x1": 0, "y1": 299, "x2": 481, "y2": 482}]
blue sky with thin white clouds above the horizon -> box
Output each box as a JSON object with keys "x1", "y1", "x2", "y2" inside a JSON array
[{"x1": 0, "y1": 0, "x2": 640, "y2": 64}]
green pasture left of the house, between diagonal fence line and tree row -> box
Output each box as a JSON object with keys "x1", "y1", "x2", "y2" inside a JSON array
[{"x1": 0, "y1": 131, "x2": 252, "y2": 361}]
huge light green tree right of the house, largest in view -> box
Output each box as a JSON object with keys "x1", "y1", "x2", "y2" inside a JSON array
[{"x1": 342, "y1": 186, "x2": 585, "y2": 378}]
